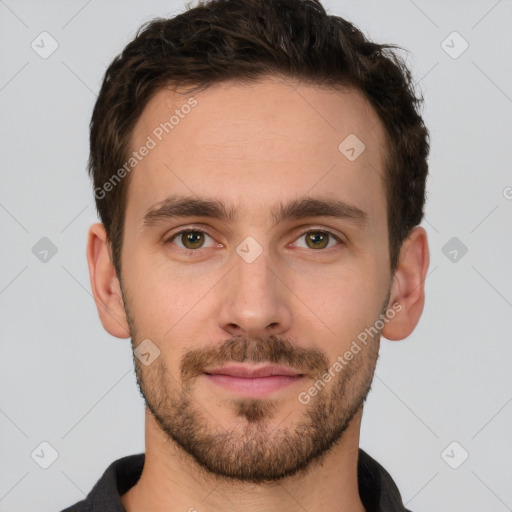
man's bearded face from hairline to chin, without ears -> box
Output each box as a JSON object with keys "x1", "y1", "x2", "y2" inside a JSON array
[{"x1": 121, "y1": 81, "x2": 391, "y2": 481}]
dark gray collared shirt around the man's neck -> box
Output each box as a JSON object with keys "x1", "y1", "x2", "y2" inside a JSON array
[{"x1": 61, "y1": 448, "x2": 411, "y2": 512}]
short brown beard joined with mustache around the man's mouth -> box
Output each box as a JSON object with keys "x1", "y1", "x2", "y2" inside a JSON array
[{"x1": 123, "y1": 278, "x2": 389, "y2": 483}]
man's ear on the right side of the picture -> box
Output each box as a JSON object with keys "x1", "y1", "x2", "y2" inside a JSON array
[{"x1": 382, "y1": 226, "x2": 430, "y2": 340}]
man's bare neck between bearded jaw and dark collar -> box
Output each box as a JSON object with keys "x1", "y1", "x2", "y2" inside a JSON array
[{"x1": 121, "y1": 408, "x2": 365, "y2": 512}]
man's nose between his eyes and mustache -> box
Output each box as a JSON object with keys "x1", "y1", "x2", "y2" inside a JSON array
[{"x1": 219, "y1": 251, "x2": 293, "y2": 337}]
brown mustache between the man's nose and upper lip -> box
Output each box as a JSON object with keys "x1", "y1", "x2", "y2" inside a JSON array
[{"x1": 180, "y1": 335, "x2": 329, "y2": 383}]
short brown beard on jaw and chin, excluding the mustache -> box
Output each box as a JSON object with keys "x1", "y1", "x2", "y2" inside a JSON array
[{"x1": 132, "y1": 337, "x2": 379, "y2": 483}]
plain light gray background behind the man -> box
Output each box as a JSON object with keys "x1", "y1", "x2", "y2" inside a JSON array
[{"x1": 0, "y1": 0, "x2": 512, "y2": 512}]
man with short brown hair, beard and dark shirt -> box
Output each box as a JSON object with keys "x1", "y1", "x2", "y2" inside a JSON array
[{"x1": 67, "y1": 0, "x2": 429, "y2": 512}]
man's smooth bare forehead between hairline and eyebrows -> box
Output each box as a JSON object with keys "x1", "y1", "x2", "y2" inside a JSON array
[{"x1": 126, "y1": 79, "x2": 387, "y2": 224}]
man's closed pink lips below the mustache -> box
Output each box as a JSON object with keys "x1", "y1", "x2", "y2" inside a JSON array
[{"x1": 204, "y1": 365, "x2": 305, "y2": 398}]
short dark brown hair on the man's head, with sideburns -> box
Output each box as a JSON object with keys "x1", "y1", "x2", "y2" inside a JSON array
[{"x1": 88, "y1": 0, "x2": 429, "y2": 278}]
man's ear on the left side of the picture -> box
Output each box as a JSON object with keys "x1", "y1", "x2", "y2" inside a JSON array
[{"x1": 87, "y1": 223, "x2": 130, "y2": 338}]
